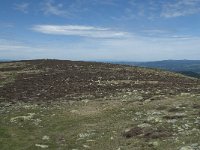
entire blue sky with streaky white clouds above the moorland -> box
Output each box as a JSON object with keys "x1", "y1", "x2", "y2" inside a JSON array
[{"x1": 0, "y1": 0, "x2": 200, "y2": 61}]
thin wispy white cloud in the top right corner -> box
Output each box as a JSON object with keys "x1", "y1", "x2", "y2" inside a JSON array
[{"x1": 161, "y1": 0, "x2": 200, "y2": 18}]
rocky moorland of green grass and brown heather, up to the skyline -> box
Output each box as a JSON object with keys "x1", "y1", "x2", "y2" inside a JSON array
[{"x1": 0, "y1": 60, "x2": 200, "y2": 150}]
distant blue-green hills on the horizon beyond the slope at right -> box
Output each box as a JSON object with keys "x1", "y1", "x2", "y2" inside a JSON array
[{"x1": 109, "y1": 60, "x2": 200, "y2": 78}]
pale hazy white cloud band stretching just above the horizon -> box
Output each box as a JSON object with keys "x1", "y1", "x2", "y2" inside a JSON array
[{"x1": 0, "y1": 33, "x2": 200, "y2": 61}]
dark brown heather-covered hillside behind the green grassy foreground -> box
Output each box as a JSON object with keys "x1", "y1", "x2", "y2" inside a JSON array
[{"x1": 0, "y1": 60, "x2": 199, "y2": 101}]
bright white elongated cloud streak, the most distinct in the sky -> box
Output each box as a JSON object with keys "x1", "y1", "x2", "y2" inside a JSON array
[{"x1": 32, "y1": 25, "x2": 129, "y2": 38}]
